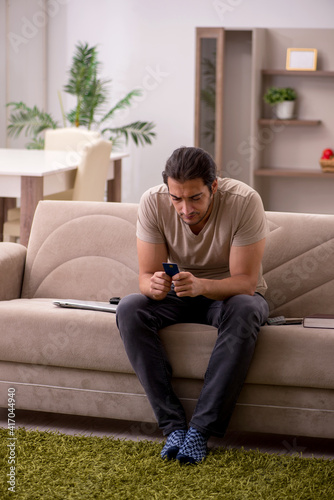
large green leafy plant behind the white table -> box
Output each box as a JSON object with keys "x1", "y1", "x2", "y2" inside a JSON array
[{"x1": 7, "y1": 42, "x2": 155, "y2": 149}]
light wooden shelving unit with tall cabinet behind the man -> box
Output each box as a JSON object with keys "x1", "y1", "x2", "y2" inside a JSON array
[{"x1": 195, "y1": 27, "x2": 334, "y2": 213}]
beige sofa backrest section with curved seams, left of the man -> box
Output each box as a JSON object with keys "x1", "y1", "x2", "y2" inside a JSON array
[{"x1": 22, "y1": 201, "x2": 139, "y2": 301}]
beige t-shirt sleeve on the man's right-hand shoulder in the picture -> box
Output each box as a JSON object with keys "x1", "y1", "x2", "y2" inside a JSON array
[{"x1": 232, "y1": 191, "x2": 268, "y2": 246}]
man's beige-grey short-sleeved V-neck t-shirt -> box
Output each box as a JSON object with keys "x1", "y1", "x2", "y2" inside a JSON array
[{"x1": 137, "y1": 178, "x2": 268, "y2": 294}]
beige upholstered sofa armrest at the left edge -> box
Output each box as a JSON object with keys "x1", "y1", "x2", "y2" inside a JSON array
[{"x1": 0, "y1": 242, "x2": 27, "y2": 300}]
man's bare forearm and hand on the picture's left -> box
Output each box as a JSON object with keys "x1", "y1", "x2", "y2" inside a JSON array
[{"x1": 137, "y1": 239, "x2": 172, "y2": 300}]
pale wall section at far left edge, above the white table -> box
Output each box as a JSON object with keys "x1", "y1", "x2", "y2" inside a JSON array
[{"x1": 0, "y1": 0, "x2": 47, "y2": 147}]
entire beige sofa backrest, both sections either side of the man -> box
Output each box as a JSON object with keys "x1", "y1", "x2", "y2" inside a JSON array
[{"x1": 22, "y1": 201, "x2": 334, "y2": 317}]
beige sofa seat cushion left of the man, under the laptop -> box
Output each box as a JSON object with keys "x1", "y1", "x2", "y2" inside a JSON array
[{"x1": 0, "y1": 299, "x2": 132, "y2": 373}]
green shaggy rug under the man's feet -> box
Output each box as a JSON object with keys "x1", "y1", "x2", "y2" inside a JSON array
[{"x1": 0, "y1": 429, "x2": 334, "y2": 500}]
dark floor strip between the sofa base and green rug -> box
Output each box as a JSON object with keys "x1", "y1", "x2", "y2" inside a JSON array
[{"x1": 0, "y1": 408, "x2": 334, "y2": 459}]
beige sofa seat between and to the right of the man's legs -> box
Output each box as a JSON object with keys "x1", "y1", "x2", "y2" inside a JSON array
[{"x1": 161, "y1": 324, "x2": 334, "y2": 389}]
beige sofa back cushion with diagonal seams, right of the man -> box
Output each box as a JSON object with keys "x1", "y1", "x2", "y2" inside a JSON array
[{"x1": 263, "y1": 212, "x2": 334, "y2": 318}]
